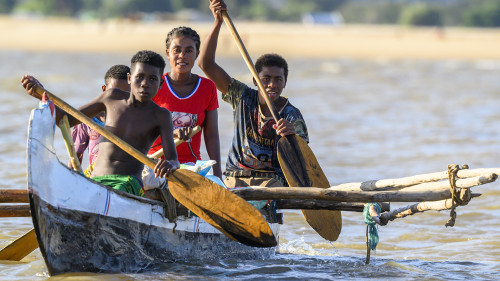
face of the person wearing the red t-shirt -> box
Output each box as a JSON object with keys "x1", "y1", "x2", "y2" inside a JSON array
[{"x1": 166, "y1": 36, "x2": 199, "y2": 73}]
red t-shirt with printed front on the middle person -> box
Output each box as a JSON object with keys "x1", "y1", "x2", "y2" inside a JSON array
[{"x1": 148, "y1": 73, "x2": 219, "y2": 163}]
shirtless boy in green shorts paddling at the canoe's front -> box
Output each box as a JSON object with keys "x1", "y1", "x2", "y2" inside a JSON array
[{"x1": 21, "y1": 51, "x2": 179, "y2": 196}]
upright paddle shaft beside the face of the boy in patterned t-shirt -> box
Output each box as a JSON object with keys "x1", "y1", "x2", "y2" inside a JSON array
[{"x1": 222, "y1": 11, "x2": 281, "y2": 122}]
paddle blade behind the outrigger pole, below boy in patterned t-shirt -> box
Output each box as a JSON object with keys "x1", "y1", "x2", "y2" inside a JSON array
[{"x1": 278, "y1": 135, "x2": 342, "y2": 241}]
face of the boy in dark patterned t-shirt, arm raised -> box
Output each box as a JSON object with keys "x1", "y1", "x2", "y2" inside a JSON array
[{"x1": 254, "y1": 66, "x2": 286, "y2": 104}]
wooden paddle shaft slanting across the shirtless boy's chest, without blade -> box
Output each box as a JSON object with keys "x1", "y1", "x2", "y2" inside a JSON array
[{"x1": 35, "y1": 86, "x2": 156, "y2": 169}]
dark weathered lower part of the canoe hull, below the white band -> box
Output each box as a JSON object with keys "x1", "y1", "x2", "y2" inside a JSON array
[{"x1": 32, "y1": 196, "x2": 274, "y2": 275}]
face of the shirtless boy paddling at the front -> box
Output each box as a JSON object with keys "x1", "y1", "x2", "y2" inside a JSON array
[{"x1": 128, "y1": 62, "x2": 162, "y2": 102}]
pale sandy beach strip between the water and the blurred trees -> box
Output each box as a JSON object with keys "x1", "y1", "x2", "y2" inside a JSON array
[{"x1": 0, "y1": 16, "x2": 500, "y2": 60}]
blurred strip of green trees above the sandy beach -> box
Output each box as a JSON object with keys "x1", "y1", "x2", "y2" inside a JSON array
[{"x1": 0, "y1": 0, "x2": 500, "y2": 27}]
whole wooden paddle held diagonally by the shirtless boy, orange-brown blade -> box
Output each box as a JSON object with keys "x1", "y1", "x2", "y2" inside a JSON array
[{"x1": 30, "y1": 87, "x2": 277, "y2": 247}]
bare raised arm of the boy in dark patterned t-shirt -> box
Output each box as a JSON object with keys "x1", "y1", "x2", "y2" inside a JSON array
[{"x1": 198, "y1": 0, "x2": 231, "y2": 93}]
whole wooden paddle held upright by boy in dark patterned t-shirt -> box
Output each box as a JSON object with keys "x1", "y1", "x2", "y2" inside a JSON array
[{"x1": 222, "y1": 11, "x2": 342, "y2": 238}]
